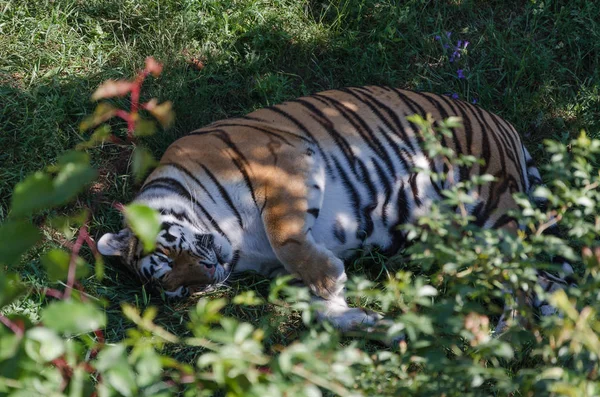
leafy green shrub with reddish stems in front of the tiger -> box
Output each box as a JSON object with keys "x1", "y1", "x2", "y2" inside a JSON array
[{"x1": 0, "y1": 61, "x2": 600, "y2": 396}]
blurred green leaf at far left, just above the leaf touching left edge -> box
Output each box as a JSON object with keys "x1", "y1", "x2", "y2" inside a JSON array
[{"x1": 11, "y1": 171, "x2": 54, "y2": 216}]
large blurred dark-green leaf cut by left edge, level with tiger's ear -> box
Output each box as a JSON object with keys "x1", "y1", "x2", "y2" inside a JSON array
[{"x1": 0, "y1": 221, "x2": 41, "y2": 265}]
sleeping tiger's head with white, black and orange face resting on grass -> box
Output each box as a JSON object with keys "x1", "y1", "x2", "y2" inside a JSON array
[{"x1": 98, "y1": 219, "x2": 230, "y2": 297}]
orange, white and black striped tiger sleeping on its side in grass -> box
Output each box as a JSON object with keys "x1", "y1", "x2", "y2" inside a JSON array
[{"x1": 98, "y1": 86, "x2": 569, "y2": 330}]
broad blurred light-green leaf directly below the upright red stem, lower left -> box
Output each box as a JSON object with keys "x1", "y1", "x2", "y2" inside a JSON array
[{"x1": 42, "y1": 300, "x2": 106, "y2": 335}]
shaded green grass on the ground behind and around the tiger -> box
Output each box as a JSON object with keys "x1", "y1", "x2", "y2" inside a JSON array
[{"x1": 0, "y1": 0, "x2": 600, "y2": 378}]
